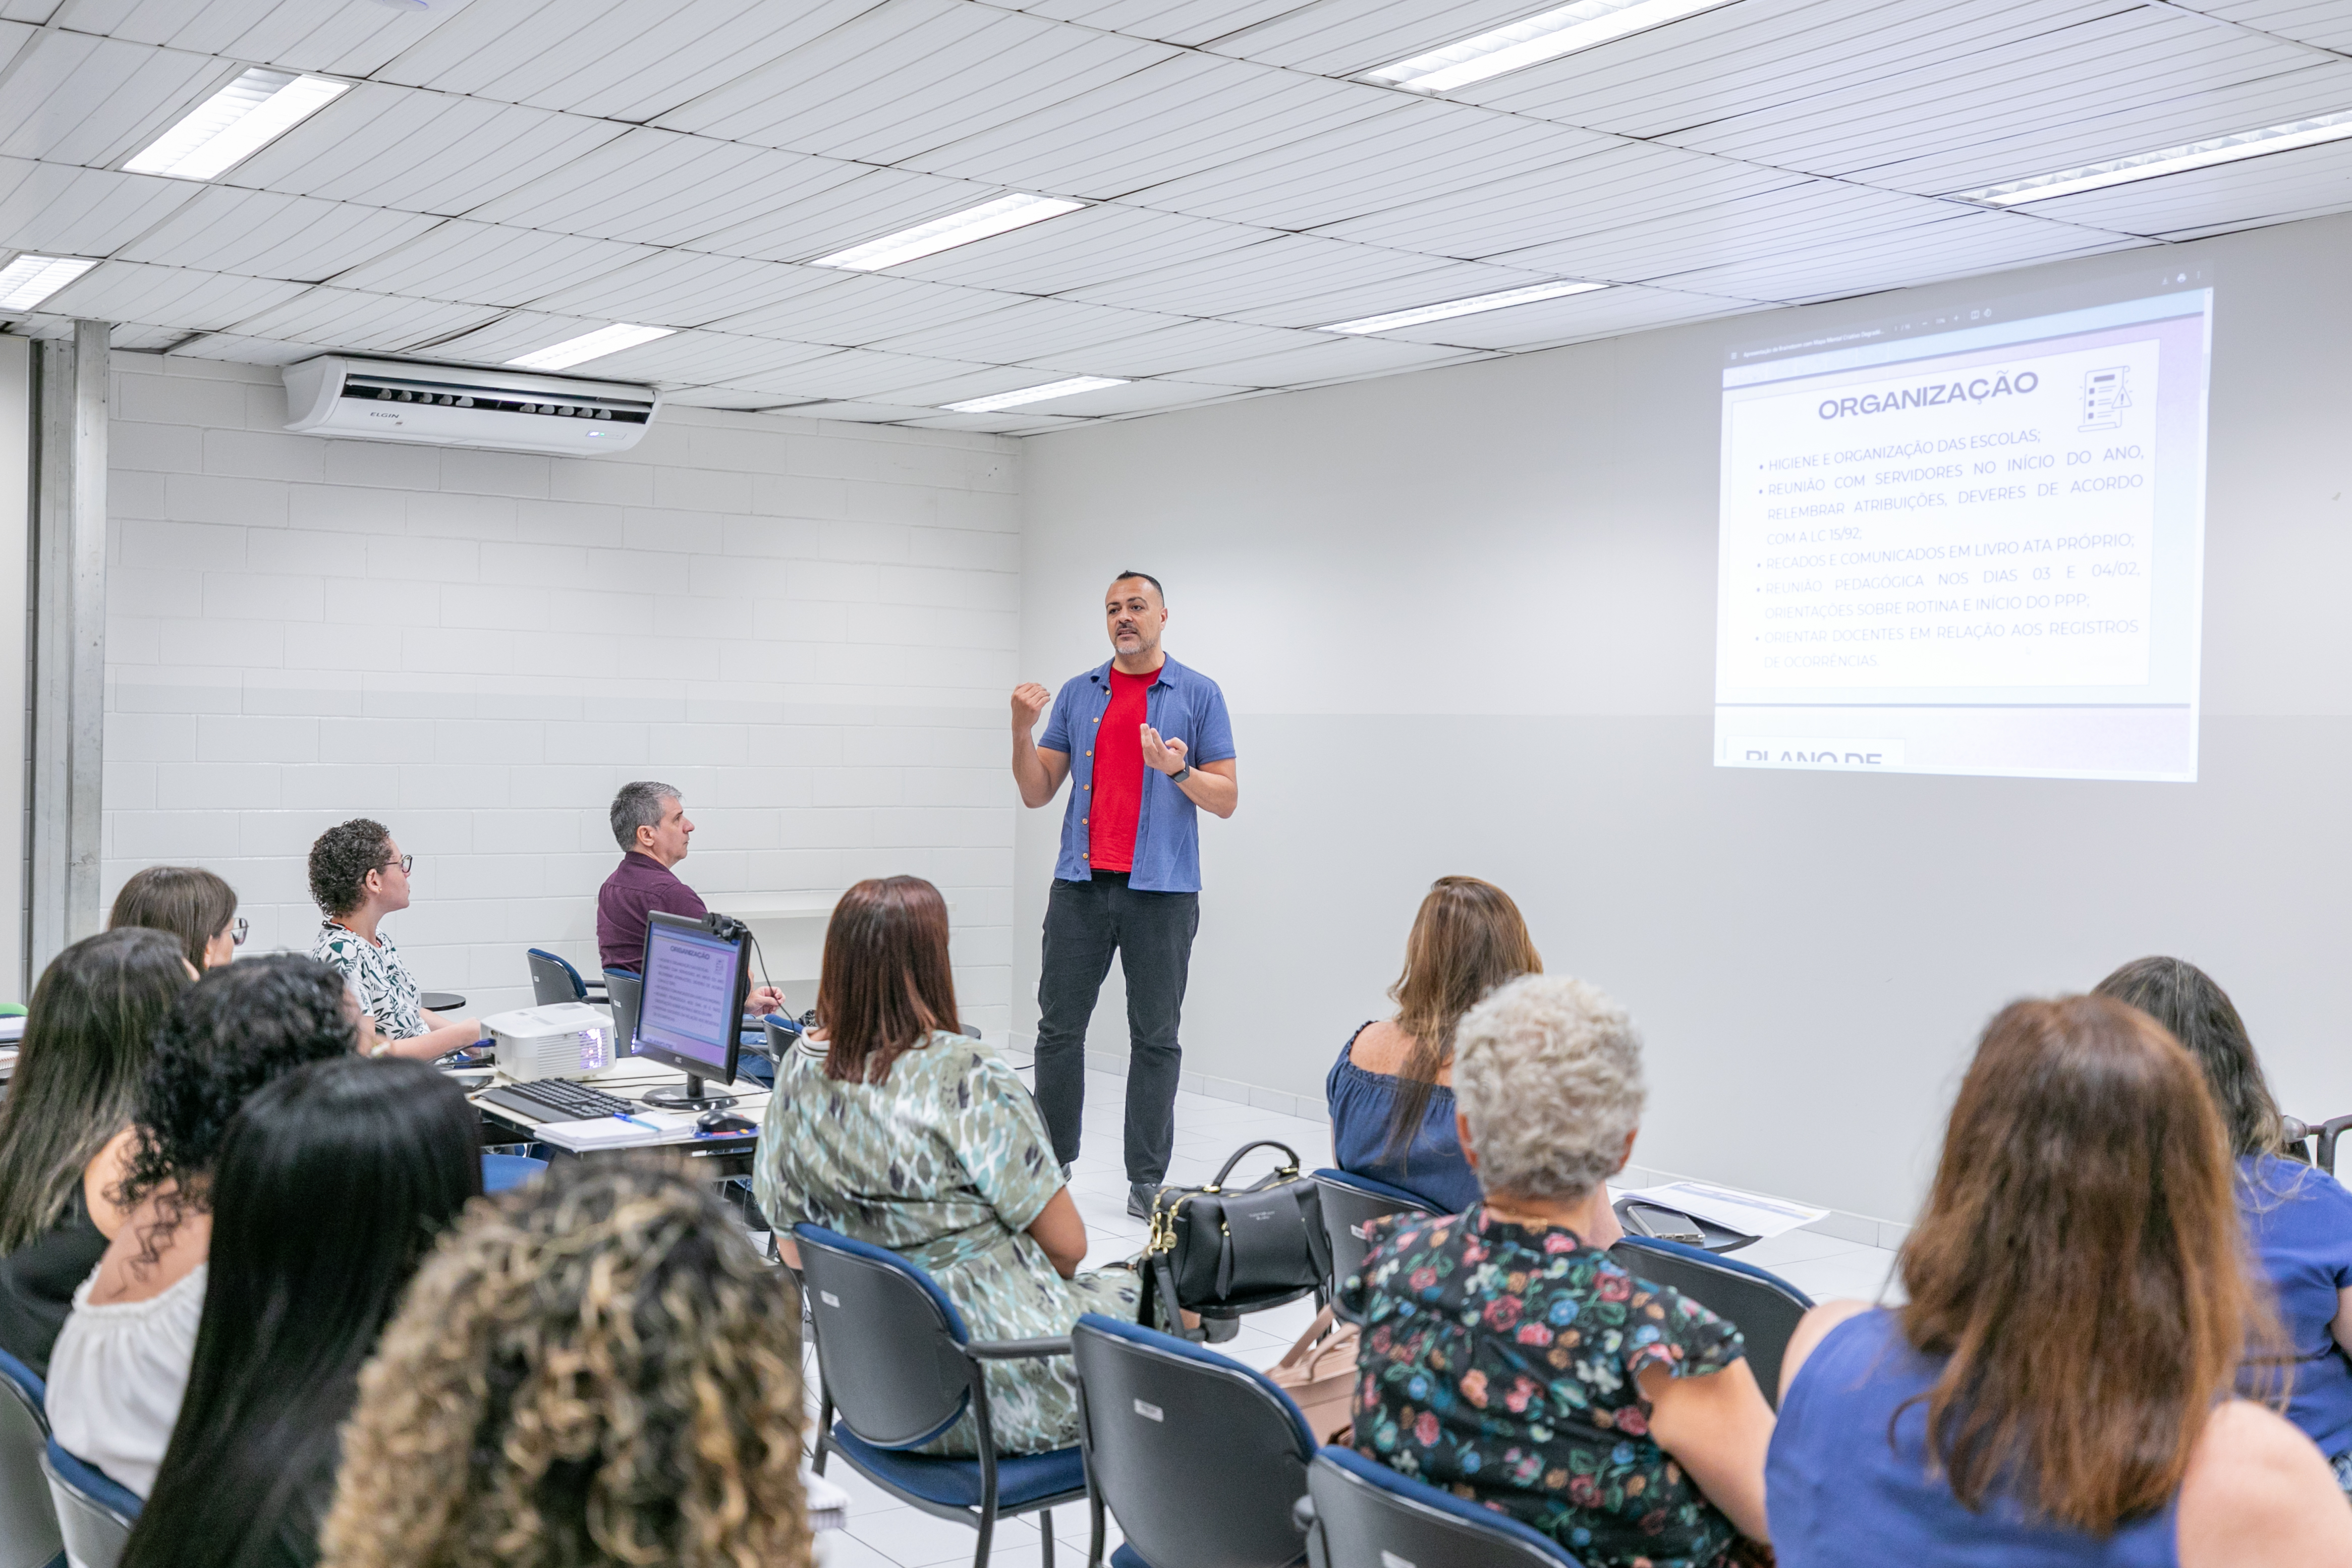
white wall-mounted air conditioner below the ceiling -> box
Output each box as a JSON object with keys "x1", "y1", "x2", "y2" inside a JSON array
[{"x1": 285, "y1": 355, "x2": 661, "y2": 456}]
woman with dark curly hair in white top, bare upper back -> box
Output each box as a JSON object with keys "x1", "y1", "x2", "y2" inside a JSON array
[{"x1": 49, "y1": 955, "x2": 360, "y2": 1497}]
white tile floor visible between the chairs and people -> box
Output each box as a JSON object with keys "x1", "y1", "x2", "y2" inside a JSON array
[{"x1": 809, "y1": 1072, "x2": 1893, "y2": 1568}]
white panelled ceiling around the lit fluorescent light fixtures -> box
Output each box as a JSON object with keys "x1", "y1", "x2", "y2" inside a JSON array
[{"x1": 0, "y1": 0, "x2": 2352, "y2": 432}]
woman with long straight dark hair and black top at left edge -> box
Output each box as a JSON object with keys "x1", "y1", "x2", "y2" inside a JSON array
[{"x1": 0, "y1": 931, "x2": 195, "y2": 1378}]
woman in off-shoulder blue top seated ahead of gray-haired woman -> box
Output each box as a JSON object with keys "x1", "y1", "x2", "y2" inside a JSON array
[{"x1": 1324, "y1": 877, "x2": 1543, "y2": 1213}]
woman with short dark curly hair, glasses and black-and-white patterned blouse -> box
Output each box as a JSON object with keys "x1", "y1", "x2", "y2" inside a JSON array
[{"x1": 310, "y1": 816, "x2": 482, "y2": 1060}]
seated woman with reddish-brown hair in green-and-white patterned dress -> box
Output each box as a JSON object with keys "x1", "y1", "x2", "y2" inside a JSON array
[{"x1": 753, "y1": 877, "x2": 1138, "y2": 1455}]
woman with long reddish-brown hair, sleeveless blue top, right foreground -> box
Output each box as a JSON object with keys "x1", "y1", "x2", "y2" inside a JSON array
[{"x1": 1764, "y1": 997, "x2": 2352, "y2": 1568}]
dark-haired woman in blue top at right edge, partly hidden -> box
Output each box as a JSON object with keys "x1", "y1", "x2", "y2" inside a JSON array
[{"x1": 2098, "y1": 959, "x2": 2352, "y2": 1490}]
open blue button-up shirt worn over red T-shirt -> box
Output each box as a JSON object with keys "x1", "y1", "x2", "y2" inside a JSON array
[{"x1": 1037, "y1": 658, "x2": 1233, "y2": 893}]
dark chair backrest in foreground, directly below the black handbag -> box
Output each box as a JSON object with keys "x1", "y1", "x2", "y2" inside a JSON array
[{"x1": 1070, "y1": 1312, "x2": 1315, "y2": 1568}]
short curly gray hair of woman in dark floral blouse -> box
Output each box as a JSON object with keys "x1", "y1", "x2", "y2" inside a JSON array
[{"x1": 1453, "y1": 976, "x2": 1649, "y2": 1199}]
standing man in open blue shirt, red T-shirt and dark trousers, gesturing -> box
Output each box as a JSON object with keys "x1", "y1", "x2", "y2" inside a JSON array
[{"x1": 1014, "y1": 571, "x2": 1240, "y2": 1218}]
